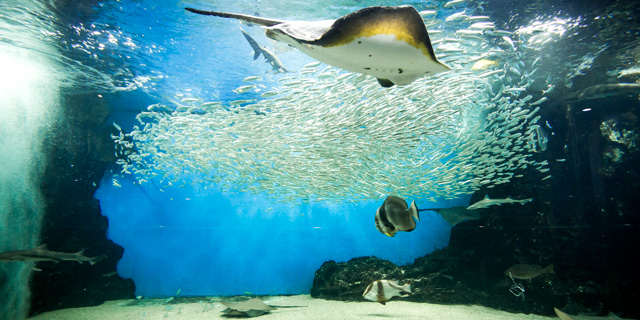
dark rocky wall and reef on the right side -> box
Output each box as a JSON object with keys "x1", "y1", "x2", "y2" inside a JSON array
[{"x1": 311, "y1": 95, "x2": 640, "y2": 318}]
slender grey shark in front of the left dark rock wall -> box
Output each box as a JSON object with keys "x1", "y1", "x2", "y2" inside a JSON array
[{"x1": 0, "y1": 244, "x2": 107, "y2": 265}]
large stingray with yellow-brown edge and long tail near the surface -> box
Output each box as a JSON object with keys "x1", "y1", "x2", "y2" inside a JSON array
[{"x1": 185, "y1": 6, "x2": 451, "y2": 87}]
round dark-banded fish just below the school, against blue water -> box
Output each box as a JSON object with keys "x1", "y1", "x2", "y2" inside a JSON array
[{"x1": 376, "y1": 196, "x2": 420, "y2": 237}]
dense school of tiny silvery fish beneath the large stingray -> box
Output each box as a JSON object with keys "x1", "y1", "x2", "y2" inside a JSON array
[{"x1": 112, "y1": 2, "x2": 552, "y2": 204}]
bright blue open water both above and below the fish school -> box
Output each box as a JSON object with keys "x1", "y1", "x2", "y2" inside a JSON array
[{"x1": 82, "y1": 1, "x2": 468, "y2": 297}]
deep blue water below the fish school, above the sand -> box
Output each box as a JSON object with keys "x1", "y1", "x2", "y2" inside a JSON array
[{"x1": 96, "y1": 174, "x2": 458, "y2": 297}]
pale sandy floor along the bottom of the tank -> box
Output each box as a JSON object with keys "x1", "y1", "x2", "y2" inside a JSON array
[{"x1": 30, "y1": 295, "x2": 557, "y2": 320}]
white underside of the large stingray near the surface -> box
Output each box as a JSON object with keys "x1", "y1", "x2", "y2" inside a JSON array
[{"x1": 274, "y1": 29, "x2": 450, "y2": 85}]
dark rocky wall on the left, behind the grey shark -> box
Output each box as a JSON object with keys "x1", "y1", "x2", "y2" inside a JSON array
[{"x1": 30, "y1": 94, "x2": 135, "y2": 315}]
